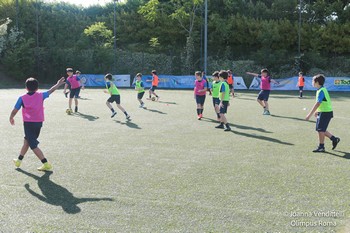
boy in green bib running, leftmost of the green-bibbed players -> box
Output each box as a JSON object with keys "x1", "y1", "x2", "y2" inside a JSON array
[{"x1": 104, "y1": 73, "x2": 130, "y2": 120}]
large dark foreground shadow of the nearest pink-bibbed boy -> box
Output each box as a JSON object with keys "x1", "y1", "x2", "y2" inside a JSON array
[{"x1": 16, "y1": 168, "x2": 113, "y2": 214}]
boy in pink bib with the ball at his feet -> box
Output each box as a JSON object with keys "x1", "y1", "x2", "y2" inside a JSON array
[{"x1": 63, "y1": 68, "x2": 84, "y2": 112}]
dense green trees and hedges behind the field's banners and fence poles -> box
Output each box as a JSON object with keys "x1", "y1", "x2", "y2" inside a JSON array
[{"x1": 0, "y1": 0, "x2": 350, "y2": 80}]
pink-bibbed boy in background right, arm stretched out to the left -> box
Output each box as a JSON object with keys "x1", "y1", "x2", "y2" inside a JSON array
[{"x1": 247, "y1": 69, "x2": 278, "y2": 115}]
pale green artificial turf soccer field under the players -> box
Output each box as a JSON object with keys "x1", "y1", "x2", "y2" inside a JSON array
[{"x1": 0, "y1": 89, "x2": 350, "y2": 233}]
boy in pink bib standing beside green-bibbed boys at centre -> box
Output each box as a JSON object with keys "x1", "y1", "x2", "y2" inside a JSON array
[{"x1": 194, "y1": 71, "x2": 207, "y2": 120}]
